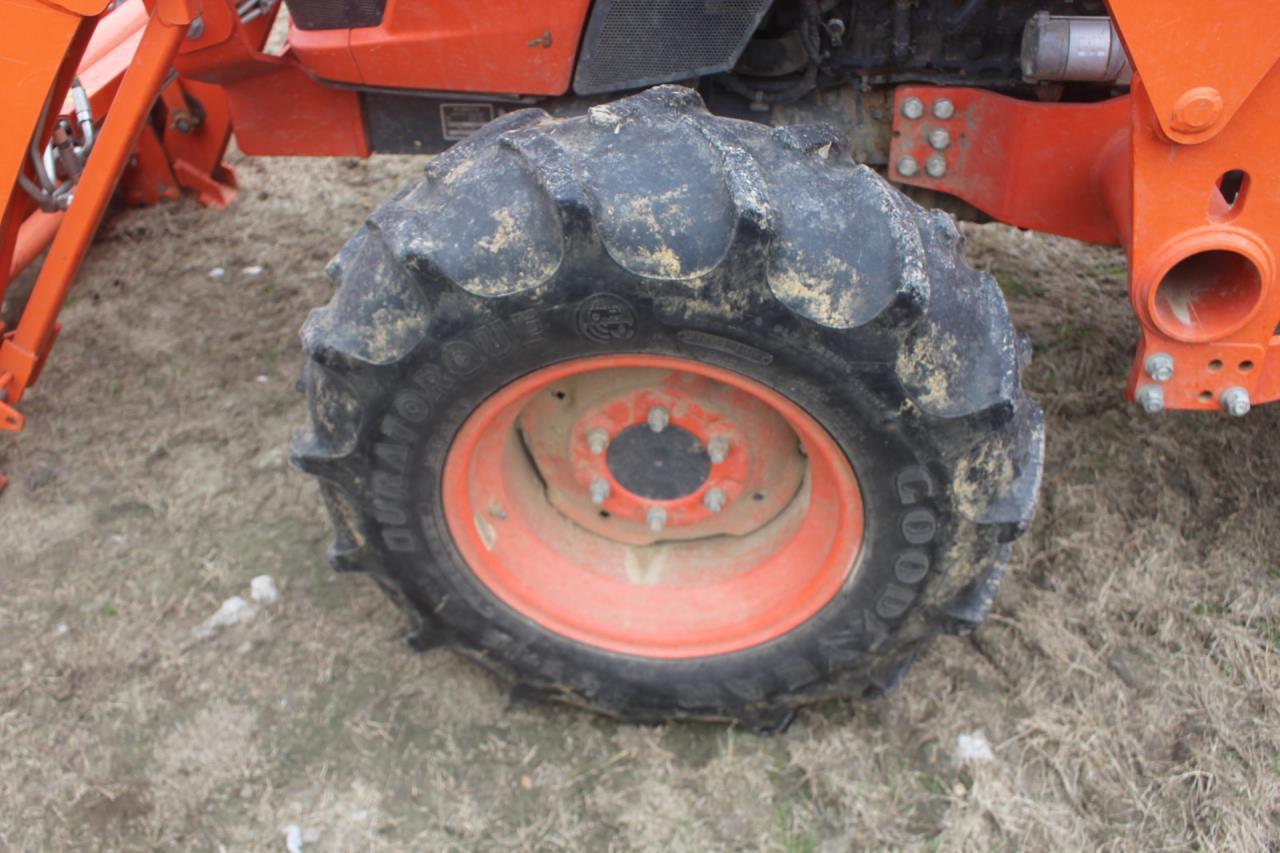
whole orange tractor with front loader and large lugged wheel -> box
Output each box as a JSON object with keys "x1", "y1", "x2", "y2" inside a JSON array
[{"x1": 0, "y1": 0, "x2": 1280, "y2": 731}]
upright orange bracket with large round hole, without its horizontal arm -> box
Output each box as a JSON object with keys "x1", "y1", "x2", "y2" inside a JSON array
[{"x1": 1119, "y1": 67, "x2": 1280, "y2": 409}]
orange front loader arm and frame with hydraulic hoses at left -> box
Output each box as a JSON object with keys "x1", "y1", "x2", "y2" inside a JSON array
[{"x1": 0, "y1": 0, "x2": 369, "y2": 488}]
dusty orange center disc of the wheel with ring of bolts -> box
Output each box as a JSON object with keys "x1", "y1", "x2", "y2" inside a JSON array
[{"x1": 520, "y1": 369, "x2": 805, "y2": 544}]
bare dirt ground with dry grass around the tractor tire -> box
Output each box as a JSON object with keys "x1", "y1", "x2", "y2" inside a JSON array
[{"x1": 0, "y1": 149, "x2": 1280, "y2": 850}]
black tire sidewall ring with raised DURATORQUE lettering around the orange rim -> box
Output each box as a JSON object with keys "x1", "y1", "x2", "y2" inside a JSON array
[{"x1": 360, "y1": 277, "x2": 961, "y2": 716}]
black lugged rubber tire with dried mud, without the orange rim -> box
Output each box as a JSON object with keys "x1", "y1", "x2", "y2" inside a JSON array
[{"x1": 293, "y1": 86, "x2": 1042, "y2": 729}]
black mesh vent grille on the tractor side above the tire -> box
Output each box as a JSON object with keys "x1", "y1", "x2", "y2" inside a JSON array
[{"x1": 573, "y1": 0, "x2": 772, "y2": 95}]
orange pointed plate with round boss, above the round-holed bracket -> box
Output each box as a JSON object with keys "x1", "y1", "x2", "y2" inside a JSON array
[{"x1": 1107, "y1": 0, "x2": 1280, "y2": 143}]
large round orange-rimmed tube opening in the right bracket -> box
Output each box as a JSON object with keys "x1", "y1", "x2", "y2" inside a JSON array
[{"x1": 1151, "y1": 248, "x2": 1262, "y2": 342}]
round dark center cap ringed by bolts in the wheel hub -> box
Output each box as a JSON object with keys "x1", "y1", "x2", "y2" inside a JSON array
[{"x1": 608, "y1": 424, "x2": 712, "y2": 501}]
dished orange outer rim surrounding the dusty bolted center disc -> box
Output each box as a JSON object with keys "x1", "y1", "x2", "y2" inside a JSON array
[{"x1": 442, "y1": 355, "x2": 863, "y2": 658}]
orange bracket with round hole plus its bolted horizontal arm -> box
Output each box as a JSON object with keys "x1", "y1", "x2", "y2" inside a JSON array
[{"x1": 891, "y1": 73, "x2": 1280, "y2": 410}]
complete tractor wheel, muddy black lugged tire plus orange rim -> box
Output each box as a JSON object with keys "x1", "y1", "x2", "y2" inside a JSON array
[{"x1": 292, "y1": 86, "x2": 1043, "y2": 730}]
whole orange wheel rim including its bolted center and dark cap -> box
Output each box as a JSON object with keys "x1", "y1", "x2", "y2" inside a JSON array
[{"x1": 443, "y1": 355, "x2": 864, "y2": 658}]
